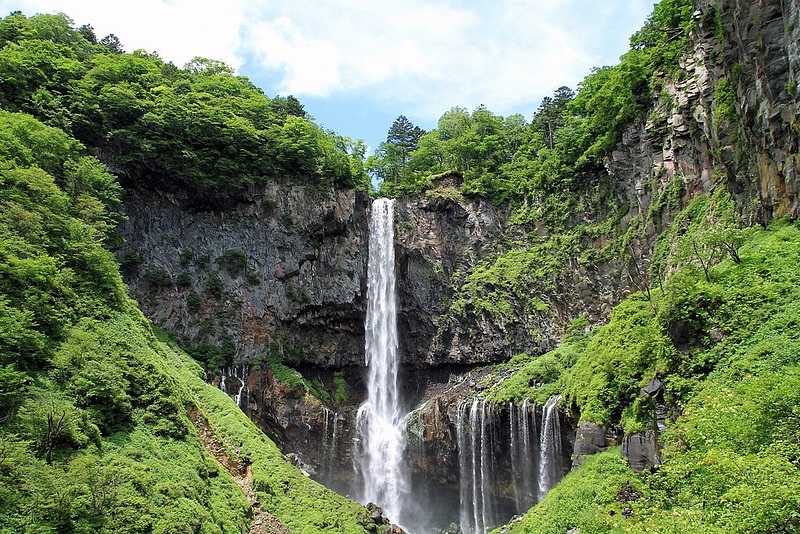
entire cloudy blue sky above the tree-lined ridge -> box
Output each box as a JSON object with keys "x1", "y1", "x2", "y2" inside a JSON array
[{"x1": 0, "y1": 0, "x2": 653, "y2": 154}]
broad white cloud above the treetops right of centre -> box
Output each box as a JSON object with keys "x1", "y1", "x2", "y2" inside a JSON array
[{"x1": 234, "y1": 0, "x2": 651, "y2": 119}]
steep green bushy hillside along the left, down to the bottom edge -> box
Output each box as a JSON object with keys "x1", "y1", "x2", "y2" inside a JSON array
[{"x1": 0, "y1": 108, "x2": 368, "y2": 533}]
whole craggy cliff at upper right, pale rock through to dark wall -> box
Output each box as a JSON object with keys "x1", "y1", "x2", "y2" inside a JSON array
[{"x1": 607, "y1": 0, "x2": 800, "y2": 228}]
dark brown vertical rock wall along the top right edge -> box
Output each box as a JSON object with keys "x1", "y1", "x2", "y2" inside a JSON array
[{"x1": 720, "y1": 0, "x2": 800, "y2": 221}]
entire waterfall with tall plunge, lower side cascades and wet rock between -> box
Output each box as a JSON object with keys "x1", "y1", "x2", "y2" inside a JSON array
[{"x1": 220, "y1": 199, "x2": 572, "y2": 534}]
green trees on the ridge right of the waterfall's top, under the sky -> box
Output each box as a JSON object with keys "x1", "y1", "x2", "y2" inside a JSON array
[{"x1": 368, "y1": 0, "x2": 692, "y2": 211}]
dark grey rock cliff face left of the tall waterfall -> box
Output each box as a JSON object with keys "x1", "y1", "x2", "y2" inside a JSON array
[{"x1": 119, "y1": 184, "x2": 369, "y2": 367}]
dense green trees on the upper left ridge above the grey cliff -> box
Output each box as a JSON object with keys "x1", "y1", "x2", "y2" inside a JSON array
[{"x1": 0, "y1": 13, "x2": 369, "y2": 208}]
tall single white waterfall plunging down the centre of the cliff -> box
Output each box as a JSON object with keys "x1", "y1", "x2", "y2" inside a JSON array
[{"x1": 353, "y1": 199, "x2": 408, "y2": 522}]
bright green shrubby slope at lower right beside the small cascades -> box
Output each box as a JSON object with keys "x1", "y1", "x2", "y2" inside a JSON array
[{"x1": 491, "y1": 210, "x2": 800, "y2": 532}]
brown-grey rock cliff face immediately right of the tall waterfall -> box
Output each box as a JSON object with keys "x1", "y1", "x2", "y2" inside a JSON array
[{"x1": 396, "y1": 186, "x2": 630, "y2": 367}]
